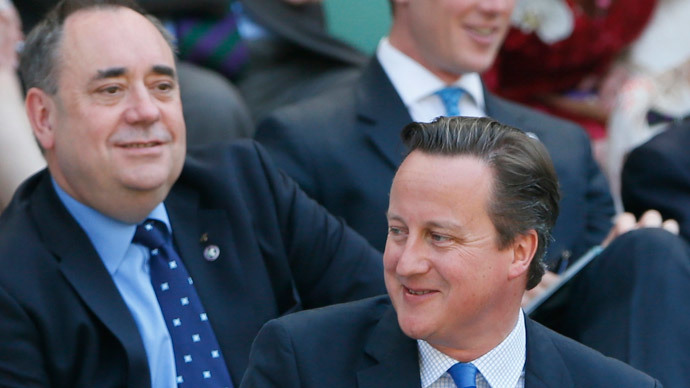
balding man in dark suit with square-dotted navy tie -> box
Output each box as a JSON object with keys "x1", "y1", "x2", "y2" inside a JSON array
[{"x1": 0, "y1": 0, "x2": 385, "y2": 388}]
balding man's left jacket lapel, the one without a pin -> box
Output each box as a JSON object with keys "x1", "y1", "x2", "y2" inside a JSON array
[{"x1": 32, "y1": 173, "x2": 151, "y2": 386}]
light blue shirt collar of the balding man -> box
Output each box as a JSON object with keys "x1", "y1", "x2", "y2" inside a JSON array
[{"x1": 51, "y1": 178, "x2": 172, "y2": 276}]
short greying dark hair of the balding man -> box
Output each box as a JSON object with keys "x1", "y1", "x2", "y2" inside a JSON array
[{"x1": 19, "y1": 0, "x2": 176, "y2": 95}]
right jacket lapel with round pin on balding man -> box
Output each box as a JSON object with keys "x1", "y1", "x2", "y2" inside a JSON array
[{"x1": 165, "y1": 187, "x2": 262, "y2": 385}]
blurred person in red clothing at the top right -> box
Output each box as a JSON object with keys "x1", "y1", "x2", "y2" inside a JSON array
[{"x1": 484, "y1": 0, "x2": 657, "y2": 140}]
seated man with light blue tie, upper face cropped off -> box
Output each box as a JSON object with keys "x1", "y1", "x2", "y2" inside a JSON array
[{"x1": 256, "y1": 0, "x2": 690, "y2": 387}]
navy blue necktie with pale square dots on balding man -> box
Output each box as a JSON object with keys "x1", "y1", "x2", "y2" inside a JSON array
[{"x1": 132, "y1": 219, "x2": 233, "y2": 388}]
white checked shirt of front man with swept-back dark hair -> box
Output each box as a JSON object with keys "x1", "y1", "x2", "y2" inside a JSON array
[{"x1": 417, "y1": 311, "x2": 527, "y2": 388}]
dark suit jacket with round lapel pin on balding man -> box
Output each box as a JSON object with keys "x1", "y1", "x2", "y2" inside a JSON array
[{"x1": 0, "y1": 141, "x2": 385, "y2": 388}]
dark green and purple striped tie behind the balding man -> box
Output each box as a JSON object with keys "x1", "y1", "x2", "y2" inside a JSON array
[{"x1": 175, "y1": 2, "x2": 249, "y2": 78}]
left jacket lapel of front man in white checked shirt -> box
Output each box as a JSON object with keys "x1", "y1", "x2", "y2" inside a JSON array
[{"x1": 357, "y1": 306, "x2": 421, "y2": 388}]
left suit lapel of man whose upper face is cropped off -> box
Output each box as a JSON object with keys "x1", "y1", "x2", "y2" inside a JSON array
[{"x1": 356, "y1": 57, "x2": 412, "y2": 169}]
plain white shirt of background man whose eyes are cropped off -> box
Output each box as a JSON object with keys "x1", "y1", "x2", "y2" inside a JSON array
[{"x1": 376, "y1": 38, "x2": 486, "y2": 122}]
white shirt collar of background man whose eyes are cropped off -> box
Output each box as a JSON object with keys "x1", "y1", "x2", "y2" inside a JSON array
[{"x1": 376, "y1": 37, "x2": 486, "y2": 111}]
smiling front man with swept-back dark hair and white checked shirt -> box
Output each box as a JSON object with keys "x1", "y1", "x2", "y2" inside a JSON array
[{"x1": 242, "y1": 117, "x2": 660, "y2": 388}]
